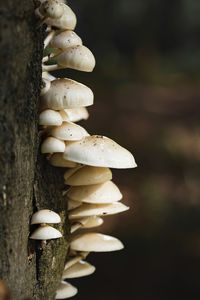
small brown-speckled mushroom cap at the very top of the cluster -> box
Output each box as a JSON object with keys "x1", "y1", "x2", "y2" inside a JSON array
[{"x1": 39, "y1": 0, "x2": 64, "y2": 19}]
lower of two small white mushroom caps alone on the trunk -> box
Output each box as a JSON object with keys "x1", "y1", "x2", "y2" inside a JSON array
[{"x1": 29, "y1": 225, "x2": 62, "y2": 240}]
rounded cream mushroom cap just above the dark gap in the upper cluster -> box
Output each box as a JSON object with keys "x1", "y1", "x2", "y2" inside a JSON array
[{"x1": 57, "y1": 45, "x2": 95, "y2": 72}]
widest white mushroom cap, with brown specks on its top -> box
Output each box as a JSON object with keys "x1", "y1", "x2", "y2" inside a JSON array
[{"x1": 64, "y1": 135, "x2": 137, "y2": 169}]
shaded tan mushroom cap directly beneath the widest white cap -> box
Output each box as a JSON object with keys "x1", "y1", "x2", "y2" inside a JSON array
[{"x1": 64, "y1": 166, "x2": 112, "y2": 186}]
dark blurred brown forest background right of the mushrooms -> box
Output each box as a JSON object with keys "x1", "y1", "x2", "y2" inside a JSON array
[{"x1": 57, "y1": 0, "x2": 200, "y2": 300}]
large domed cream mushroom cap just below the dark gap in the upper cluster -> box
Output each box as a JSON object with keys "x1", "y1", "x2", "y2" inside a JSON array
[{"x1": 41, "y1": 78, "x2": 94, "y2": 110}]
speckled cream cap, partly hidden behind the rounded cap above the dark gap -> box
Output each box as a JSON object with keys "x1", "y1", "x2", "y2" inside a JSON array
[{"x1": 50, "y1": 30, "x2": 82, "y2": 50}]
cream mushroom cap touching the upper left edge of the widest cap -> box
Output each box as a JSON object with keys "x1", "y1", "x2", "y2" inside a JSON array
[{"x1": 48, "y1": 122, "x2": 89, "y2": 141}]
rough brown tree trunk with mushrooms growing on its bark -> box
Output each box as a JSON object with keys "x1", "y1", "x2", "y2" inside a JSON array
[{"x1": 0, "y1": 0, "x2": 68, "y2": 300}]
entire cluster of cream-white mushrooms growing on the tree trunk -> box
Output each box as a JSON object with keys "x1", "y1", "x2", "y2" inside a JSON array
[{"x1": 34, "y1": 0, "x2": 137, "y2": 299}]
